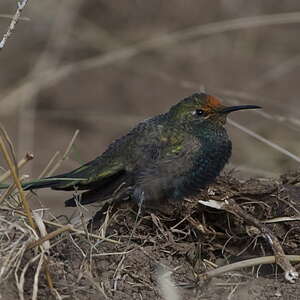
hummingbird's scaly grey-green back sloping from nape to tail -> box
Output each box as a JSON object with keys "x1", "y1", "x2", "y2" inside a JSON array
[{"x1": 51, "y1": 114, "x2": 170, "y2": 190}]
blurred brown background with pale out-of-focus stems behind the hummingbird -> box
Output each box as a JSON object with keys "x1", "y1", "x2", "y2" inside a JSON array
[{"x1": 0, "y1": 0, "x2": 300, "y2": 213}]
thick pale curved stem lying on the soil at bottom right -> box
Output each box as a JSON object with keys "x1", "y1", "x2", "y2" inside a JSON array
[{"x1": 200, "y1": 255, "x2": 300, "y2": 279}]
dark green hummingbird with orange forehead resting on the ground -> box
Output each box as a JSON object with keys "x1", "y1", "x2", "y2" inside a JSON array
[{"x1": 0, "y1": 93, "x2": 261, "y2": 206}]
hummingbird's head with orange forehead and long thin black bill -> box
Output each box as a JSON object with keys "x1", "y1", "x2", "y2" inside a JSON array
[{"x1": 169, "y1": 93, "x2": 261, "y2": 126}]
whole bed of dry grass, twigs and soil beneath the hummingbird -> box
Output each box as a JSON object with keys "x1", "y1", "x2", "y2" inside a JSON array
[{"x1": 0, "y1": 172, "x2": 300, "y2": 299}]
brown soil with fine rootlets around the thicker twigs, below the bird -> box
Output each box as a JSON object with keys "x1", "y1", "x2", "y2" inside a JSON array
[{"x1": 0, "y1": 172, "x2": 300, "y2": 300}]
